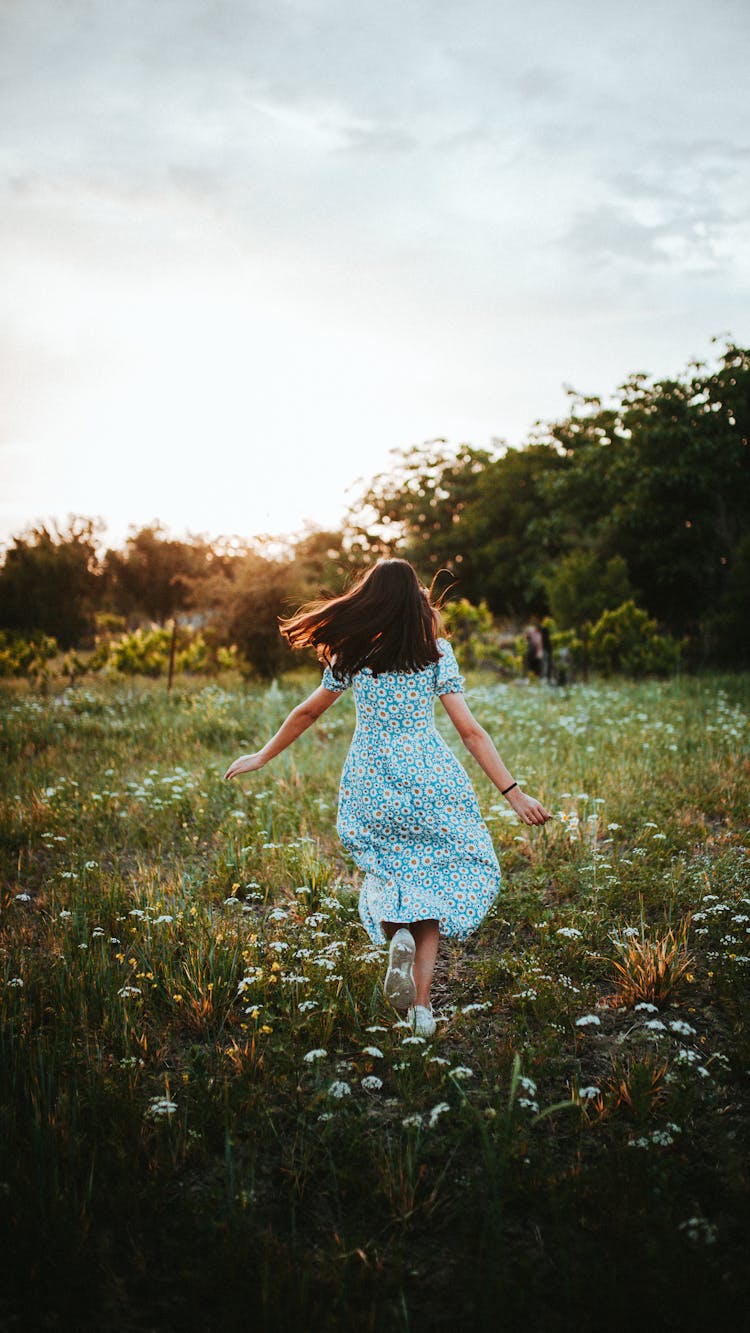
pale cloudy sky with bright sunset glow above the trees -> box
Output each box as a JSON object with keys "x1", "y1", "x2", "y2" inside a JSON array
[{"x1": 0, "y1": 0, "x2": 750, "y2": 544}]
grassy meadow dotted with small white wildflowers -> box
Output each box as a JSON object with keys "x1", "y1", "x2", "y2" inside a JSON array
[{"x1": 0, "y1": 672, "x2": 750, "y2": 1333}]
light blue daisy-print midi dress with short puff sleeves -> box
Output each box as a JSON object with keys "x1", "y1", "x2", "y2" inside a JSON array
[{"x1": 322, "y1": 639, "x2": 501, "y2": 944}]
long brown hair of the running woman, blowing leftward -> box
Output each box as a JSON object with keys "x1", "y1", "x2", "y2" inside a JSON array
[{"x1": 278, "y1": 560, "x2": 442, "y2": 680}]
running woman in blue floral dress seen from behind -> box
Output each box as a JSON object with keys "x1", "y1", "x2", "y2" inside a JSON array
[{"x1": 224, "y1": 560, "x2": 552, "y2": 1037}]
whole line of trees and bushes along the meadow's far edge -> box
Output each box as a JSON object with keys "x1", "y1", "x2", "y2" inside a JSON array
[{"x1": 0, "y1": 343, "x2": 750, "y2": 676}]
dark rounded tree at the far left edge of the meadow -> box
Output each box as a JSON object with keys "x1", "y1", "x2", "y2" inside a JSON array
[{"x1": 0, "y1": 516, "x2": 103, "y2": 648}]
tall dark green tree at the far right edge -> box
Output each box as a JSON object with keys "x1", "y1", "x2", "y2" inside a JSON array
[{"x1": 538, "y1": 344, "x2": 750, "y2": 643}]
